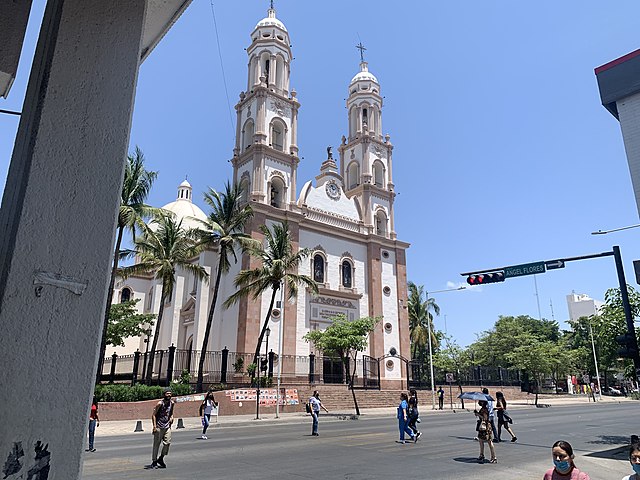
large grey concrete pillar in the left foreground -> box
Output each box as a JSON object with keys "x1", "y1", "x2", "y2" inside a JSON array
[{"x1": 0, "y1": 0, "x2": 146, "y2": 479}]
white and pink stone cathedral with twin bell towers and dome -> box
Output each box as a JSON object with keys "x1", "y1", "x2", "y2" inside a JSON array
[{"x1": 114, "y1": 8, "x2": 410, "y2": 388}]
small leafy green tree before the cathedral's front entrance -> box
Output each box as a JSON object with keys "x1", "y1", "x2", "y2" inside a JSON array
[{"x1": 303, "y1": 315, "x2": 382, "y2": 415}]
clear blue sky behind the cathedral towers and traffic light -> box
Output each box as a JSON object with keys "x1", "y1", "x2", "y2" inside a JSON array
[{"x1": 0, "y1": 0, "x2": 640, "y2": 345}]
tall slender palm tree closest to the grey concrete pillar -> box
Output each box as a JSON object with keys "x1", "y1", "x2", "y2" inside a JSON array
[{"x1": 96, "y1": 147, "x2": 158, "y2": 383}]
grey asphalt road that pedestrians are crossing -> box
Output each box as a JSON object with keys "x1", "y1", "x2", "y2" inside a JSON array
[{"x1": 82, "y1": 402, "x2": 640, "y2": 480}]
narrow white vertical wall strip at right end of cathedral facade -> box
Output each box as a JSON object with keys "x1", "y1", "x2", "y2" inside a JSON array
[{"x1": 380, "y1": 251, "x2": 401, "y2": 378}]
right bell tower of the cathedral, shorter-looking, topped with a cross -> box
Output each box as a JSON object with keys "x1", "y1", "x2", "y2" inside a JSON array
[{"x1": 339, "y1": 43, "x2": 396, "y2": 239}]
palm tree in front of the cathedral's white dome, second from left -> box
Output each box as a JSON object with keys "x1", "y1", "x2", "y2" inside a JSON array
[{"x1": 120, "y1": 213, "x2": 209, "y2": 384}]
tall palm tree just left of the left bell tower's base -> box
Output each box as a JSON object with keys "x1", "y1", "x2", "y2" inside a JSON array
[{"x1": 196, "y1": 182, "x2": 253, "y2": 392}]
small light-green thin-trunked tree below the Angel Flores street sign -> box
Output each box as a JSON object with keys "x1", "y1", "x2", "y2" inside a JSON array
[{"x1": 506, "y1": 333, "x2": 557, "y2": 405}]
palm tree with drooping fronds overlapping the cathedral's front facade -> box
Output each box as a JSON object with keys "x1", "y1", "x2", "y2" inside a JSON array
[{"x1": 223, "y1": 221, "x2": 318, "y2": 377}]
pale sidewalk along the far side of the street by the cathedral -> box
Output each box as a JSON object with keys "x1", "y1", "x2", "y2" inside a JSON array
[{"x1": 96, "y1": 395, "x2": 635, "y2": 436}]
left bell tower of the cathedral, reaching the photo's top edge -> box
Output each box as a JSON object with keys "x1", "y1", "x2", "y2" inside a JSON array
[{"x1": 232, "y1": 2, "x2": 300, "y2": 209}]
